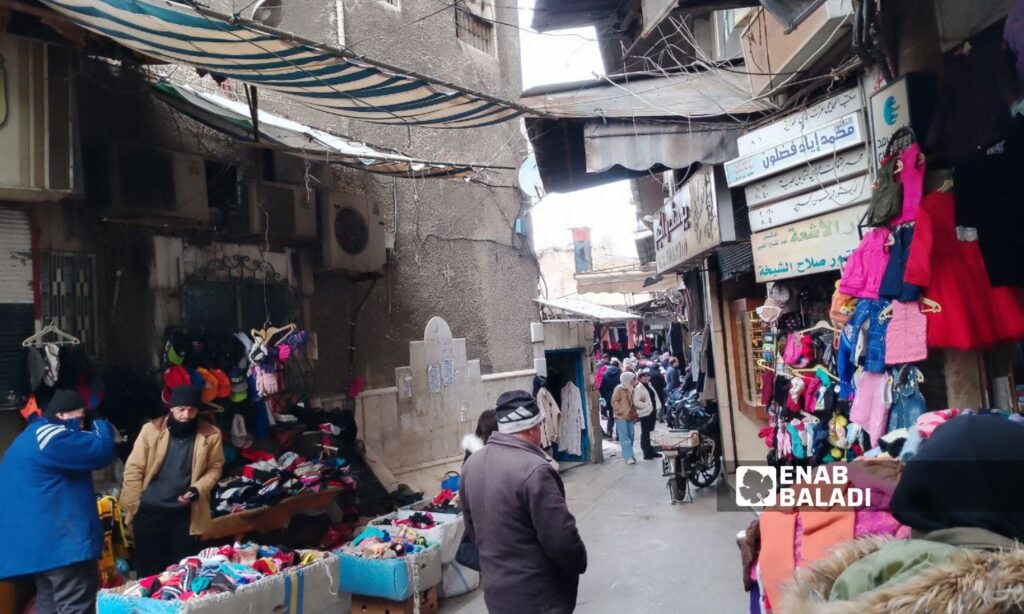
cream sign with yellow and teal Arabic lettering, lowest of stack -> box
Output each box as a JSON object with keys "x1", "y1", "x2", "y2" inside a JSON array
[{"x1": 751, "y1": 205, "x2": 867, "y2": 283}]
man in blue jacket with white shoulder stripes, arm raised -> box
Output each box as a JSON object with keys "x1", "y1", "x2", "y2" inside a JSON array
[{"x1": 0, "y1": 390, "x2": 114, "y2": 614}]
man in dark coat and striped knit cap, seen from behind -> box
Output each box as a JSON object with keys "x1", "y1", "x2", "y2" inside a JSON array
[{"x1": 461, "y1": 391, "x2": 587, "y2": 614}]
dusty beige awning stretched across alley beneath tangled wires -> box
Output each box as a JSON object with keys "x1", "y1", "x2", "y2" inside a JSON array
[{"x1": 519, "y1": 70, "x2": 771, "y2": 119}]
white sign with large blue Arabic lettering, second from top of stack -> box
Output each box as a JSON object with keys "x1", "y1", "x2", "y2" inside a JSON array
[{"x1": 725, "y1": 112, "x2": 864, "y2": 187}]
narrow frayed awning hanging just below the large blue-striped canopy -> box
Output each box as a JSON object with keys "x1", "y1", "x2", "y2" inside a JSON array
[{"x1": 153, "y1": 82, "x2": 495, "y2": 177}]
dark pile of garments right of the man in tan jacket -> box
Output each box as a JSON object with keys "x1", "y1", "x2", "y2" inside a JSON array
[{"x1": 213, "y1": 451, "x2": 357, "y2": 516}]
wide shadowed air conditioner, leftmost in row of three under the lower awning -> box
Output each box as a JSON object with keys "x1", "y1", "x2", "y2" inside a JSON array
[{"x1": 92, "y1": 143, "x2": 210, "y2": 223}]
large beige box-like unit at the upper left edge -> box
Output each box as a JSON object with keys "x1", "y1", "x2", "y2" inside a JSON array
[{"x1": 0, "y1": 37, "x2": 78, "y2": 202}]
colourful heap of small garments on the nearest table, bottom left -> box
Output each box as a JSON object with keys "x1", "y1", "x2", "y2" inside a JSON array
[{"x1": 124, "y1": 542, "x2": 330, "y2": 602}]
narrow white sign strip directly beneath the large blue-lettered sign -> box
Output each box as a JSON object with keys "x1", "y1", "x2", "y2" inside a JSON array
[{"x1": 743, "y1": 147, "x2": 870, "y2": 207}]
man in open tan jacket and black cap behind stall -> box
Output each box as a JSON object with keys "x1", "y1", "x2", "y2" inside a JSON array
[{"x1": 121, "y1": 385, "x2": 224, "y2": 578}]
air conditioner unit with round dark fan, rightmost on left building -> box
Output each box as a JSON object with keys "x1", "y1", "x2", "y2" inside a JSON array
[{"x1": 319, "y1": 192, "x2": 387, "y2": 274}]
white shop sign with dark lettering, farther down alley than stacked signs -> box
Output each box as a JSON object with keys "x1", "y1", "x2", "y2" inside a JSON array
[{"x1": 654, "y1": 166, "x2": 736, "y2": 273}]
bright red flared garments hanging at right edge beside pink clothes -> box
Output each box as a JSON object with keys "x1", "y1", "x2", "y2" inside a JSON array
[{"x1": 903, "y1": 191, "x2": 1024, "y2": 350}]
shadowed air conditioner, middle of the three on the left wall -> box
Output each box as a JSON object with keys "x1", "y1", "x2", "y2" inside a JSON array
[{"x1": 248, "y1": 181, "x2": 316, "y2": 240}]
